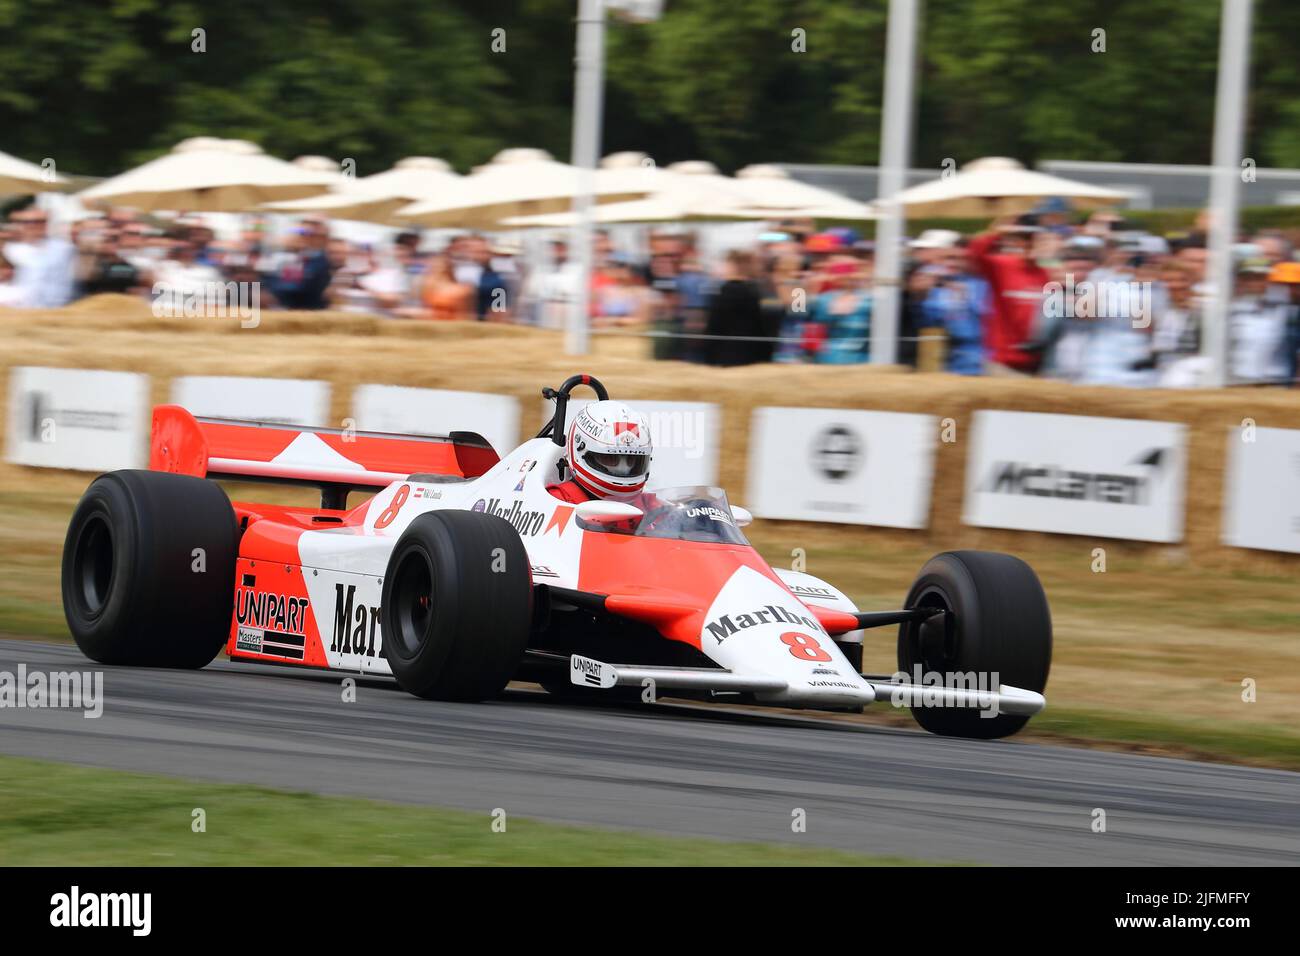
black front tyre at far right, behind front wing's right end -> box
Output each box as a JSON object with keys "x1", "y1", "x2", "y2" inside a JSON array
[{"x1": 898, "y1": 551, "x2": 1052, "y2": 740}]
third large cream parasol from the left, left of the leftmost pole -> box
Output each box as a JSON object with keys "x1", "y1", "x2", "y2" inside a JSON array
[{"x1": 265, "y1": 156, "x2": 464, "y2": 225}]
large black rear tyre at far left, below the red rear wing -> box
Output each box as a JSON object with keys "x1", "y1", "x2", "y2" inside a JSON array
[{"x1": 62, "y1": 471, "x2": 239, "y2": 667}]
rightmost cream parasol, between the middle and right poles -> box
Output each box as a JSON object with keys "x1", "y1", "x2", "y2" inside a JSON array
[{"x1": 896, "y1": 156, "x2": 1128, "y2": 219}]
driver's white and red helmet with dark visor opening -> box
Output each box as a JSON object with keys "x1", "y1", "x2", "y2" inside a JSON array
[{"x1": 566, "y1": 402, "x2": 654, "y2": 498}]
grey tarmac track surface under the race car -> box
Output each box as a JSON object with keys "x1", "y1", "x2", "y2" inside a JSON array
[{"x1": 0, "y1": 640, "x2": 1300, "y2": 865}]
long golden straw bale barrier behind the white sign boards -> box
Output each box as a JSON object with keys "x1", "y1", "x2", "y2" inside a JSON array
[{"x1": 0, "y1": 295, "x2": 1300, "y2": 574}]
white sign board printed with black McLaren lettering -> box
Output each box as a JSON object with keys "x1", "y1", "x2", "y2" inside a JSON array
[{"x1": 965, "y1": 411, "x2": 1186, "y2": 541}]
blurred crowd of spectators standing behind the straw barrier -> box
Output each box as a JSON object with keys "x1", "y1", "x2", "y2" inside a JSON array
[{"x1": 0, "y1": 200, "x2": 1300, "y2": 386}]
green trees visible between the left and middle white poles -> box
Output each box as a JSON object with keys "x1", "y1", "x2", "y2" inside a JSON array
[{"x1": 608, "y1": 0, "x2": 884, "y2": 169}]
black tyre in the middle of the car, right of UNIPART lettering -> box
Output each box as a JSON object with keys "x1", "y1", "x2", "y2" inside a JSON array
[{"x1": 381, "y1": 511, "x2": 533, "y2": 701}]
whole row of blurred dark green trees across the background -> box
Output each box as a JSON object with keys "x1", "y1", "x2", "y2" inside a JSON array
[{"x1": 0, "y1": 0, "x2": 1300, "y2": 183}]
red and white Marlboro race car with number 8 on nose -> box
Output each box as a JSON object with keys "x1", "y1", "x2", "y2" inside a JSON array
[{"x1": 62, "y1": 375, "x2": 1052, "y2": 737}]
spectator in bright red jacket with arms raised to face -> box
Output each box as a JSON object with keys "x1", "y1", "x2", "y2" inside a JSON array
[{"x1": 966, "y1": 217, "x2": 1050, "y2": 375}]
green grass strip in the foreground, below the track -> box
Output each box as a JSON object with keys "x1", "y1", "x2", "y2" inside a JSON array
[{"x1": 0, "y1": 757, "x2": 915, "y2": 866}]
